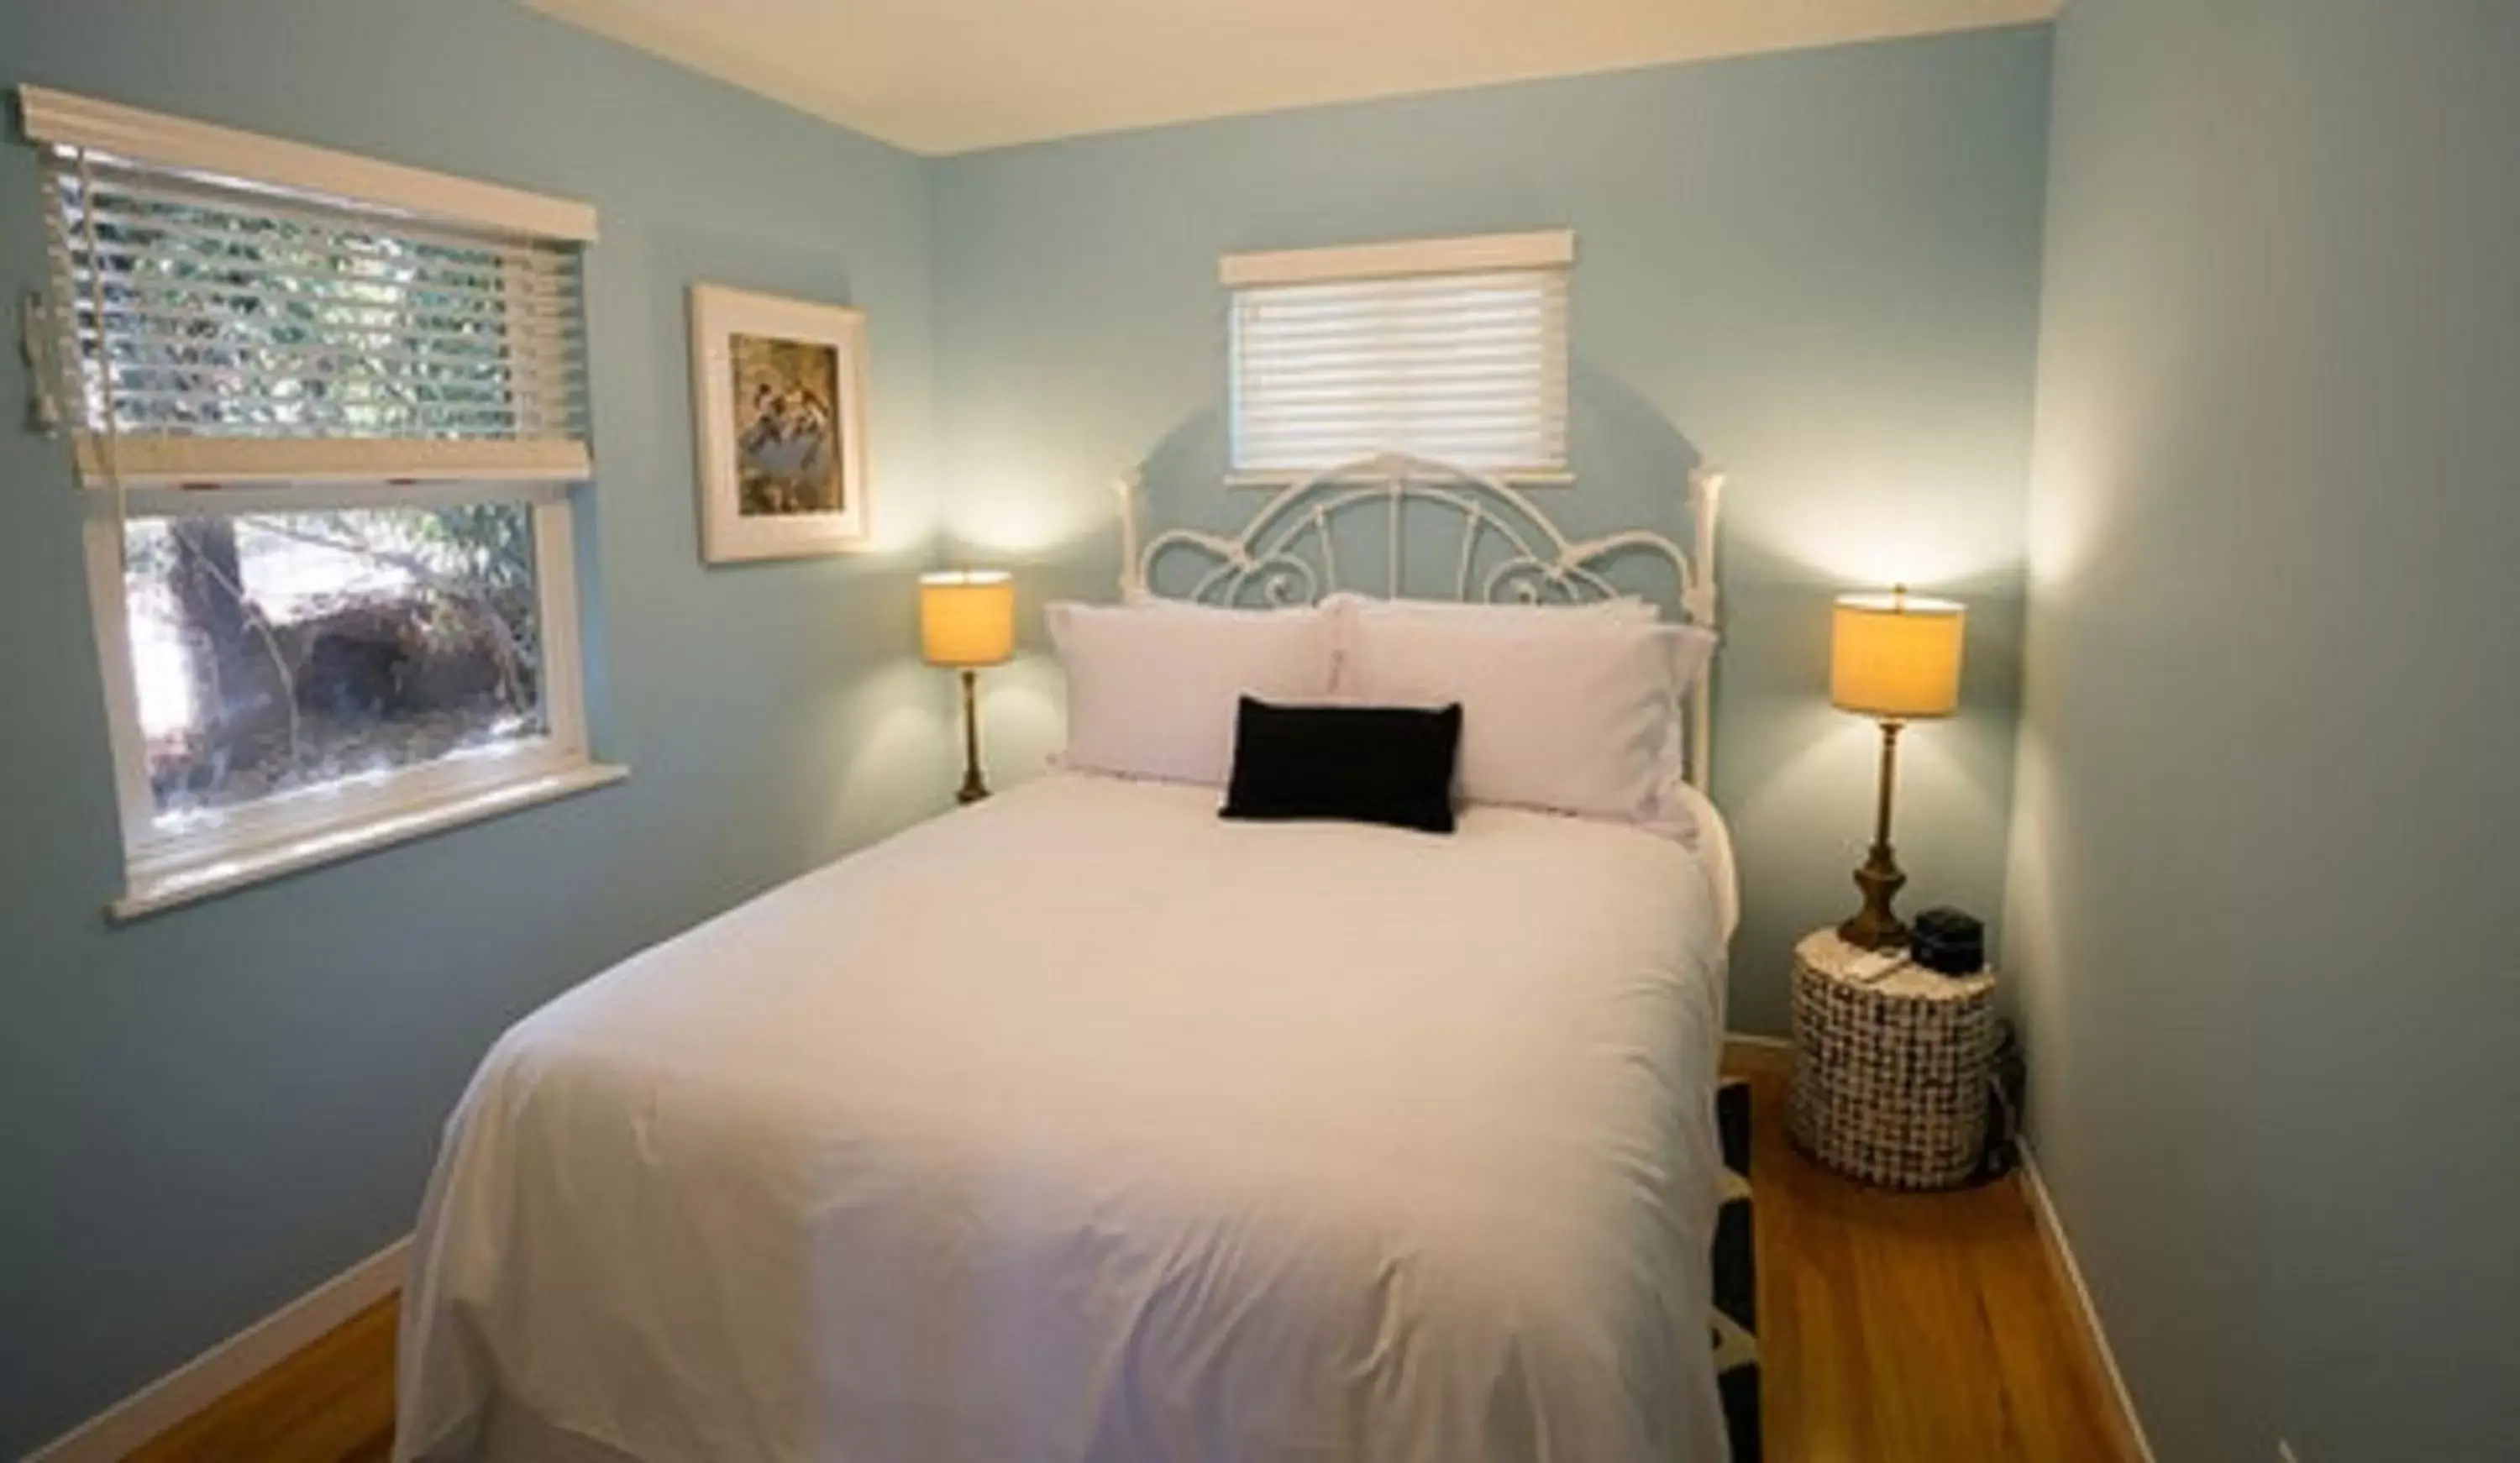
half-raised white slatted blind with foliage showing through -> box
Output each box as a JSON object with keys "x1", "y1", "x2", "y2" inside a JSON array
[{"x1": 45, "y1": 149, "x2": 592, "y2": 484}]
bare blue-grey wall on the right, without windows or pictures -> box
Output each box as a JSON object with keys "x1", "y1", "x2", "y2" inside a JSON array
[{"x1": 2006, "y1": 0, "x2": 2520, "y2": 1463}]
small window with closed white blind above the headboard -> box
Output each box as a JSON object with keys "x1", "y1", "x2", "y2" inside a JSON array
[{"x1": 1222, "y1": 234, "x2": 1575, "y2": 479}]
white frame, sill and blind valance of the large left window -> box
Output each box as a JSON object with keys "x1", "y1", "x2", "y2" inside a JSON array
[{"x1": 20, "y1": 86, "x2": 627, "y2": 919}]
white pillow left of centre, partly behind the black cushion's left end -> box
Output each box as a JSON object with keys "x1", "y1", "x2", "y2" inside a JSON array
[{"x1": 1043, "y1": 605, "x2": 1338, "y2": 788}]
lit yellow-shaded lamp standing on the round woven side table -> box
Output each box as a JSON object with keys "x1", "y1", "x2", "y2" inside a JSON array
[{"x1": 1830, "y1": 585, "x2": 1968, "y2": 949}]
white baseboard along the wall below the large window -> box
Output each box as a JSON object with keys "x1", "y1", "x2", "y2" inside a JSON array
[{"x1": 25, "y1": 1234, "x2": 411, "y2": 1463}]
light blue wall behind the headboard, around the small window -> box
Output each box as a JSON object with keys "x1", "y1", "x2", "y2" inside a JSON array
[{"x1": 935, "y1": 28, "x2": 2049, "y2": 1032}]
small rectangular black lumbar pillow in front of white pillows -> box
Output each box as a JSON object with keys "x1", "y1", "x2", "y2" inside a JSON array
[{"x1": 1225, "y1": 695, "x2": 1462, "y2": 833}]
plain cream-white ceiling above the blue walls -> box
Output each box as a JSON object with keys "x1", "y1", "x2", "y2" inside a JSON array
[{"x1": 522, "y1": 0, "x2": 2056, "y2": 154}]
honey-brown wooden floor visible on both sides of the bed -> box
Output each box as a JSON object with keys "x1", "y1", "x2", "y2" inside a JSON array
[{"x1": 118, "y1": 1047, "x2": 2139, "y2": 1463}]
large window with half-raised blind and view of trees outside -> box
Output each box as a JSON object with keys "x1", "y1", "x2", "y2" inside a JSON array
[{"x1": 20, "y1": 88, "x2": 617, "y2": 911}]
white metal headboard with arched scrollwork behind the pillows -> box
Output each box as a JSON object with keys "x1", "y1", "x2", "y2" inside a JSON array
[{"x1": 1116, "y1": 454, "x2": 1724, "y2": 793}]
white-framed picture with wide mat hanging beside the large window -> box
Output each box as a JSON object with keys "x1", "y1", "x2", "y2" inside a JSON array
[{"x1": 690, "y1": 285, "x2": 874, "y2": 564}]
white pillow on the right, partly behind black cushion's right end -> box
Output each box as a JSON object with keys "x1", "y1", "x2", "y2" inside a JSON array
[{"x1": 1341, "y1": 607, "x2": 1704, "y2": 823}]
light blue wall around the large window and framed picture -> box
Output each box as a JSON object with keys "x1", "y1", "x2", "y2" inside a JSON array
[{"x1": 0, "y1": 0, "x2": 953, "y2": 1455}]
